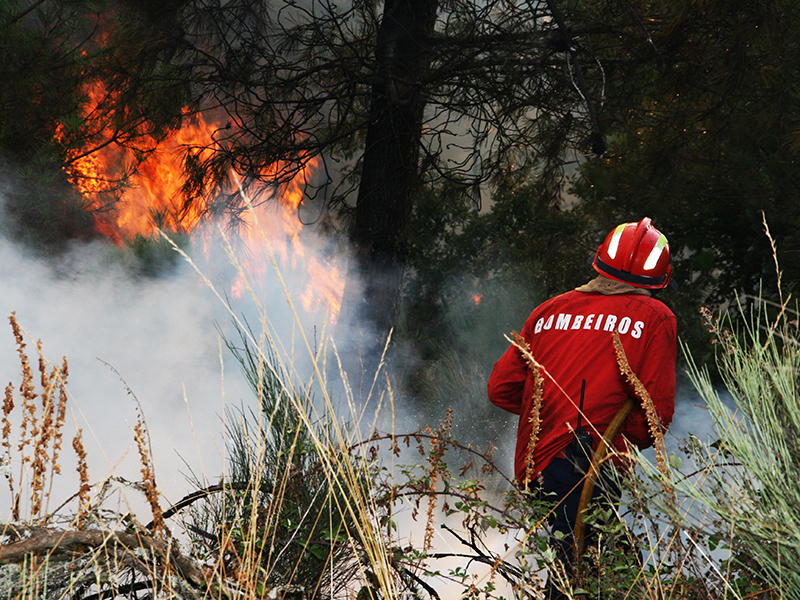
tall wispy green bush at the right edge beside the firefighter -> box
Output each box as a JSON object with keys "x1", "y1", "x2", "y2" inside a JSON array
[{"x1": 628, "y1": 298, "x2": 800, "y2": 599}]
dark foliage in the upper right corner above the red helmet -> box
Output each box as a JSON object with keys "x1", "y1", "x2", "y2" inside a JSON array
[{"x1": 572, "y1": 0, "x2": 800, "y2": 312}]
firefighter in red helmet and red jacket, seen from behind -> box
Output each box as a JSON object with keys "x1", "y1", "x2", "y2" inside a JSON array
[{"x1": 488, "y1": 218, "x2": 676, "y2": 584}]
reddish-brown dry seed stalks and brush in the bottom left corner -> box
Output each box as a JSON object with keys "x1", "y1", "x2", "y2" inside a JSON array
[{"x1": 0, "y1": 313, "x2": 205, "y2": 600}]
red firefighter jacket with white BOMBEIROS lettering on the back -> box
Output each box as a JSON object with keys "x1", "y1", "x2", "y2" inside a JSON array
[{"x1": 488, "y1": 290, "x2": 676, "y2": 483}]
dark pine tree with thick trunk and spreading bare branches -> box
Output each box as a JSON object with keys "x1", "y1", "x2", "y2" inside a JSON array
[{"x1": 169, "y1": 0, "x2": 597, "y2": 333}]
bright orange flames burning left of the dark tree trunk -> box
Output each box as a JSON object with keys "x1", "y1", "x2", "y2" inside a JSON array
[{"x1": 56, "y1": 84, "x2": 344, "y2": 320}]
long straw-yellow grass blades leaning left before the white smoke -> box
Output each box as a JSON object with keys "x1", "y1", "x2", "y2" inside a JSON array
[{"x1": 156, "y1": 184, "x2": 406, "y2": 598}]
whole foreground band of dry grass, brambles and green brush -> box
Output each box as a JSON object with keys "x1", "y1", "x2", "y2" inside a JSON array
[{"x1": 0, "y1": 230, "x2": 798, "y2": 600}]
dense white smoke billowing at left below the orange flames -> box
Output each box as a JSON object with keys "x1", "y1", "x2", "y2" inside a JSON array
[{"x1": 0, "y1": 186, "x2": 346, "y2": 522}]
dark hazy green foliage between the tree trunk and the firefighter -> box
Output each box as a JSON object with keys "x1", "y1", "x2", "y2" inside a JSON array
[{"x1": 398, "y1": 184, "x2": 599, "y2": 404}]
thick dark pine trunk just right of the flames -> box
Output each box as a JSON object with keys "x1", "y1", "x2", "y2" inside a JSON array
[{"x1": 343, "y1": 0, "x2": 437, "y2": 352}]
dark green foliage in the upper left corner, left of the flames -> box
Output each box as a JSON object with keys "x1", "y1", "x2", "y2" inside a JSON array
[{"x1": 0, "y1": 0, "x2": 107, "y2": 249}]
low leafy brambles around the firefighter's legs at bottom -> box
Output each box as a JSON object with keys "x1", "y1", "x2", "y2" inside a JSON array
[{"x1": 369, "y1": 414, "x2": 770, "y2": 600}]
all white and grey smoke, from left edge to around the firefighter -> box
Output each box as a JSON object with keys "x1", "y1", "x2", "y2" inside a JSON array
[{"x1": 0, "y1": 169, "x2": 713, "y2": 552}]
